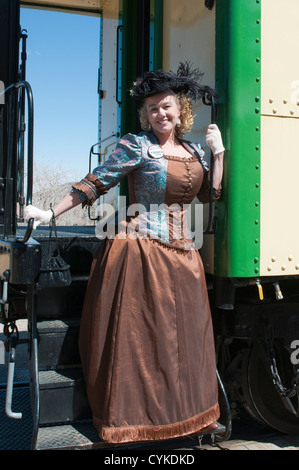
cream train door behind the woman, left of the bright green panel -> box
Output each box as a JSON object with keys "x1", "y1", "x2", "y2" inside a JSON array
[{"x1": 163, "y1": 0, "x2": 215, "y2": 274}]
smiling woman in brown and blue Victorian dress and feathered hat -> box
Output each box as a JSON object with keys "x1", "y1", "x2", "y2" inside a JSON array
[{"x1": 26, "y1": 65, "x2": 224, "y2": 443}]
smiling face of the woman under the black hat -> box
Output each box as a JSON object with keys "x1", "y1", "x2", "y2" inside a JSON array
[{"x1": 145, "y1": 91, "x2": 180, "y2": 135}]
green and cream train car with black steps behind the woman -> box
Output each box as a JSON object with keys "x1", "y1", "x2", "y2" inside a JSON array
[{"x1": 0, "y1": 0, "x2": 299, "y2": 449}]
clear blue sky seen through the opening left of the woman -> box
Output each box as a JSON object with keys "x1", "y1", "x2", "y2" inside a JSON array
[{"x1": 21, "y1": 8, "x2": 100, "y2": 181}]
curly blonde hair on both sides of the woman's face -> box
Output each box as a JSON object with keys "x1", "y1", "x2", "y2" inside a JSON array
[{"x1": 139, "y1": 92, "x2": 195, "y2": 137}]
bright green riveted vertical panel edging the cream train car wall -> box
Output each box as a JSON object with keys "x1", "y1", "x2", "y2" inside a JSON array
[{"x1": 215, "y1": 0, "x2": 261, "y2": 277}]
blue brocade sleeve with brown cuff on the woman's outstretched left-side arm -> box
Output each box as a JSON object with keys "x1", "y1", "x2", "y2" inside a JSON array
[{"x1": 72, "y1": 134, "x2": 142, "y2": 206}]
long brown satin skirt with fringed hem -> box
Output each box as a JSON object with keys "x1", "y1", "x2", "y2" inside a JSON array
[{"x1": 79, "y1": 238, "x2": 219, "y2": 443}]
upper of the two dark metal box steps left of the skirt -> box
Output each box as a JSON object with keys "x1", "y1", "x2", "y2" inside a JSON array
[{"x1": 37, "y1": 318, "x2": 80, "y2": 367}]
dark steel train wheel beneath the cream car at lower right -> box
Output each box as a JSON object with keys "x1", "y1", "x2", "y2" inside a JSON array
[{"x1": 242, "y1": 343, "x2": 299, "y2": 434}]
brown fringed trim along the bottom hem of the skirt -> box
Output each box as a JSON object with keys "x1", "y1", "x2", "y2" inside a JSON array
[{"x1": 93, "y1": 403, "x2": 220, "y2": 444}]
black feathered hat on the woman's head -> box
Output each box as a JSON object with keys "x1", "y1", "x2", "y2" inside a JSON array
[{"x1": 130, "y1": 62, "x2": 216, "y2": 103}]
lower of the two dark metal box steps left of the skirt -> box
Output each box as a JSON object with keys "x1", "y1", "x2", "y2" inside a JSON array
[{"x1": 39, "y1": 368, "x2": 91, "y2": 425}]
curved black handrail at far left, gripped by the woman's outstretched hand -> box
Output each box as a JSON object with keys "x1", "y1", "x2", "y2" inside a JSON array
[{"x1": 1, "y1": 80, "x2": 34, "y2": 243}]
